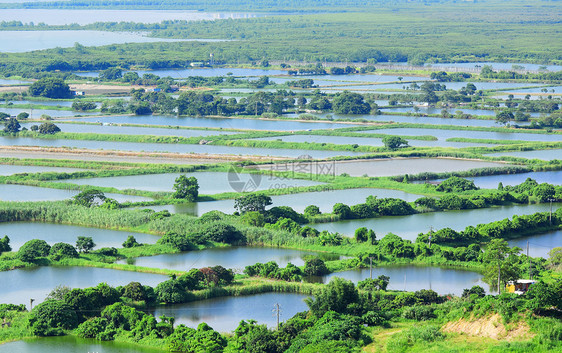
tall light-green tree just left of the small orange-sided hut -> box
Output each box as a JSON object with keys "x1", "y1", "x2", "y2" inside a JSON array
[{"x1": 484, "y1": 238, "x2": 521, "y2": 292}]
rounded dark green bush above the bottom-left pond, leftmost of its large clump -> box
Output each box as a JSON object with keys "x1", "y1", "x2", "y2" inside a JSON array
[{"x1": 29, "y1": 300, "x2": 78, "y2": 336}]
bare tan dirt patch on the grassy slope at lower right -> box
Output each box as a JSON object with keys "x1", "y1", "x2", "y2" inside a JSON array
[{"x1": 443, "y1": 314, "x2": 534, "y2": 341}]
